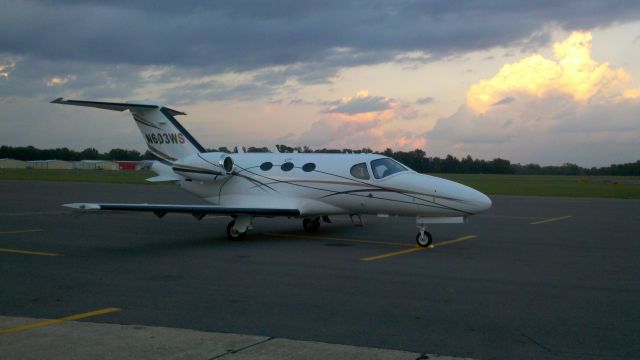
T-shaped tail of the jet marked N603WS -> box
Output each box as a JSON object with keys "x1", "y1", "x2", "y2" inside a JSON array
[{"x1": 52, "y1": 98, "x2": 206, "y2": 163}]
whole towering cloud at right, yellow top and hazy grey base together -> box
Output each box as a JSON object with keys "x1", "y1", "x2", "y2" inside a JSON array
[{"x1": 425, "y1": 33, "x2": 640, "y2": 166}]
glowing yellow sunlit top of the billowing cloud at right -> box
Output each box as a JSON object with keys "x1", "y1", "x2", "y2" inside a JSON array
[{"x1": 467, "y1": 32, "x2": 629, "y2": 112}]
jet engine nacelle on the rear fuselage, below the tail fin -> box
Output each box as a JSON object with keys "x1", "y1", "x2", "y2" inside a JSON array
[{"x1": 171, "y1": 152, "x2": 235, "y2": 181}]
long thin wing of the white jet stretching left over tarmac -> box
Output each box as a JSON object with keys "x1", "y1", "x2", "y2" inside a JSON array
[{"x1": 62, "y1": 203, "x2": 300, "y2": 218}]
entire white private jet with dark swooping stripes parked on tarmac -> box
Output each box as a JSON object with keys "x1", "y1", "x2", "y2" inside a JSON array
[{"x1": 52, "y1": 98, "x2": 491, "y2": 246}]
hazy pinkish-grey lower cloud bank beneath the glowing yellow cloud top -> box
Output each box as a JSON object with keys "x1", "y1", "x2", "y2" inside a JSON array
[{"x1": 425, "y1": 95, "x2": 640, "y2": 166}]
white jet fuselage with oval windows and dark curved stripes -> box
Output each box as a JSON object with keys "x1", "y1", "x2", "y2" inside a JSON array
[{"x1": 173, "y1": 152, "x2": 491, "y2": 217}]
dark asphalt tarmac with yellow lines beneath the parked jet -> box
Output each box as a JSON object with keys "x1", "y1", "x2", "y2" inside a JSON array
[{"x1": 0, "y1": 181, "x2": 640, "y2": 359}]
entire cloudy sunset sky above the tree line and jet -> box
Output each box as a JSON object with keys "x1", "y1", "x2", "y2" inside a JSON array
[{"x1": 0, "y1": 0, "x2": 640, "y2": 166}]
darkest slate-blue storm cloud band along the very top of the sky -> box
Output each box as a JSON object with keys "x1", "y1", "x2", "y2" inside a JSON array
[{"x1": 0, "y1": 0, "x2": 640, "y2": 71}]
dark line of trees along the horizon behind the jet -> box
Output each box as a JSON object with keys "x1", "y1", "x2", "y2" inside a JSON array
[{"x1": 0, "y1": 145, "x2": 640, "y2": 176}]
